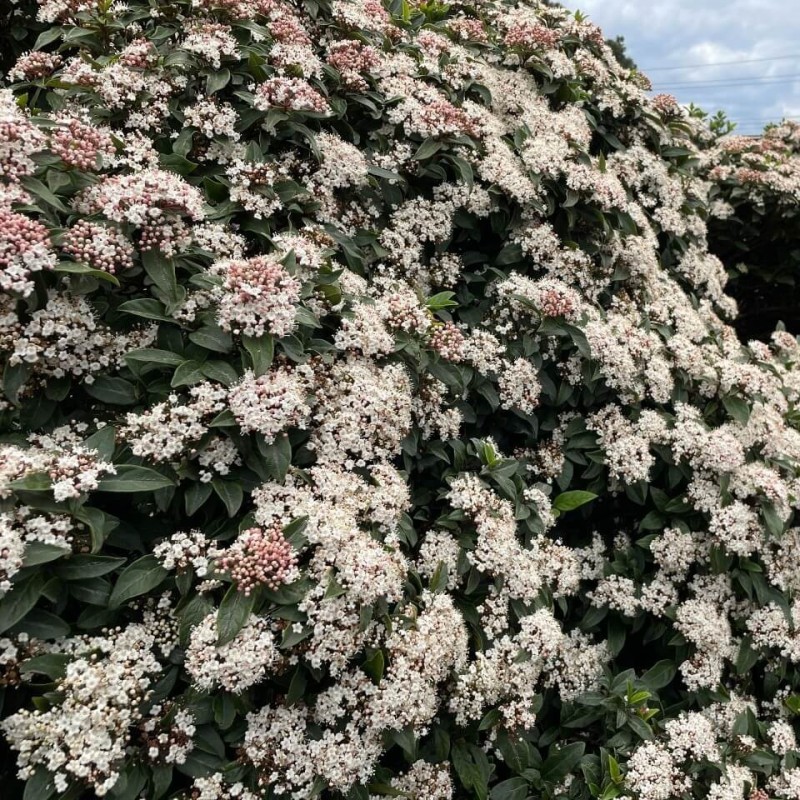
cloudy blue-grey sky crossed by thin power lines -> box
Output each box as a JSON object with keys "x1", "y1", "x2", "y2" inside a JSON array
[{"x1": 565, "y1": 0, "x2": 800, "y2": 133}]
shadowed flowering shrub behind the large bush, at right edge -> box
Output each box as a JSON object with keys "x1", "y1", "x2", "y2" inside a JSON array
[{"x1": 703, "y1": 121, "x2": 800, "y2": 339}]
